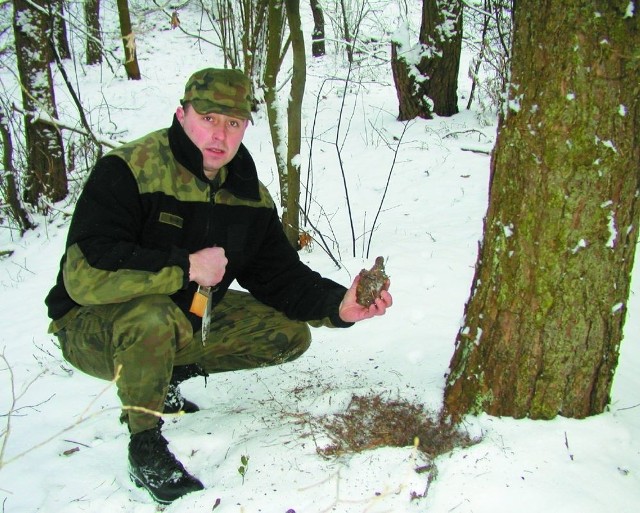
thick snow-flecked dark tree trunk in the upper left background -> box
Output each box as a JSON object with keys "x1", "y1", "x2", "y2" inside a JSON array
[{"x1": 13, "y1": 0, "x2": 68, "y2": 208}]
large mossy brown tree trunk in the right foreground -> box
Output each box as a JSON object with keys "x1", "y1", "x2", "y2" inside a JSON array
[{"x1": 445, "y1": 0, "x2": 640, "y2": 419}]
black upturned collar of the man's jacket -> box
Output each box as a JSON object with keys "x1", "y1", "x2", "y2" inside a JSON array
[{"x1": 169, "y1": 114, "x2": 260, "y2": 201}]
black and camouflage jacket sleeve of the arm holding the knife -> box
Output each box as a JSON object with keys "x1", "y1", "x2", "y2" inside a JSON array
[{"x1": 62, "y1": 157, "x2": 189, "y2": 305}]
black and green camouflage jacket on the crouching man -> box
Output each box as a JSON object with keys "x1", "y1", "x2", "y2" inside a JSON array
[{"x1": 45, "y1": 117, "x2": 350, "y2": 331}]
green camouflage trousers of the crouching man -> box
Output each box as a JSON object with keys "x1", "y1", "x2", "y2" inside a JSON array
[{"x1": 55, "y1": 290, "x2": 311, "y2": 433}]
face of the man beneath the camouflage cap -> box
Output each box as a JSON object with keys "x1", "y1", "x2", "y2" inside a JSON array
[{"x1": 176, "y1": 105, "x2": 249, "y2": 179}]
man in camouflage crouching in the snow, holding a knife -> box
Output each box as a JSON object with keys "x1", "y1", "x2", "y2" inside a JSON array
[{"x1": 46, "y1": 68, "x2": 392, "y2": 503}]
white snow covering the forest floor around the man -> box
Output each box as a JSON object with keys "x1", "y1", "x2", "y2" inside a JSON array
[{"x1": 0, "y1": 6, "x2": 640, "y2": 513}]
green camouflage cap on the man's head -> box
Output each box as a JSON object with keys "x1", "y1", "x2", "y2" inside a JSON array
[{"x1": 180, "y1": 68, "x2": 253, "y2": 121}]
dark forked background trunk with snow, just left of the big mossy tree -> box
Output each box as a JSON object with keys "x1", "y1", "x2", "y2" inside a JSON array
[{"x1": 392, "y1": 0, "x2": 462, "y2": 121}]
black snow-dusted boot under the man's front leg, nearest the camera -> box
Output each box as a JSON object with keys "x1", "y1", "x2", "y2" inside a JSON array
[{"x1": 129, "y1": 425, "x2": 204, "y2": 504}]
